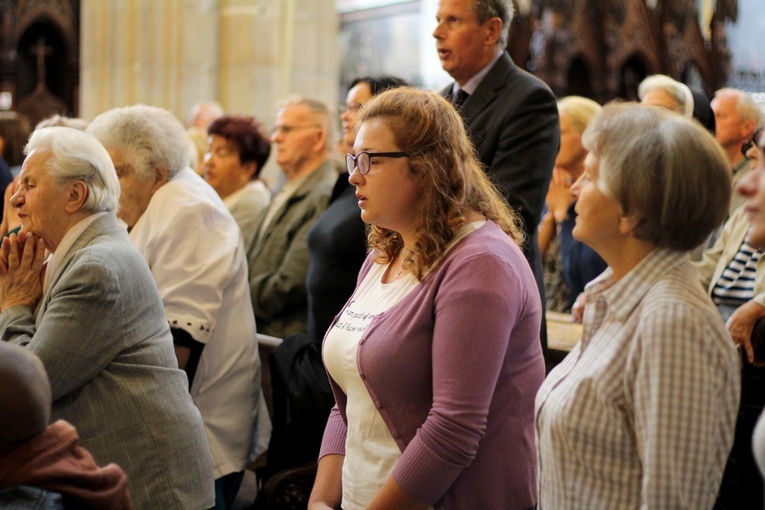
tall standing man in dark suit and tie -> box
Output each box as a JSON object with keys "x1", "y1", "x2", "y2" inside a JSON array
[{"x1": 433, "y1": 0, "x2": 560, "y2": 350}]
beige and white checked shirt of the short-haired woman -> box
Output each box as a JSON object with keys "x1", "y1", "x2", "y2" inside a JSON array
[{"x1": 535, "y1": 249, "x2": 740, "y2": 510}]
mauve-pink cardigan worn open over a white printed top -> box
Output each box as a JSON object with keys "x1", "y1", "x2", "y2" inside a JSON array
[{"x1": 320, "y1": 221, "x2": 544, "y2": 510}]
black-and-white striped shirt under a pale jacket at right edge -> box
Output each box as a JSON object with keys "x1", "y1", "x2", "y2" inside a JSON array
[{"x1": 712, "y1": 239, "x2": 763, "y2": 306}]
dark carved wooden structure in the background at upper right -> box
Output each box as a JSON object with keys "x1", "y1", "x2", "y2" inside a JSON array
[{"x1": 508, "y1": 0, "x2": 738, "y2": 103}]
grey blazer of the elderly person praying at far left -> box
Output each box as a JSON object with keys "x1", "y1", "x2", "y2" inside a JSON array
[{"x1": 0, "y1": 214, "x2": 214, "y2": 509}]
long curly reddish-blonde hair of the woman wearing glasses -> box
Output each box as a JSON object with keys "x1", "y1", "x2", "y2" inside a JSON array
[{"x1": 358, "y1": 87, "x2": 523, "y2": 280}]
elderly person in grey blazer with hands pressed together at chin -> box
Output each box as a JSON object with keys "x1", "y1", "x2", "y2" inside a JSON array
[{"x1": 0, "y1": 127, "x2": 214, "y2": 509}]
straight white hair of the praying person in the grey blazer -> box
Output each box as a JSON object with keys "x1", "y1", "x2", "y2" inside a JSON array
[{"x1": 24, "y1": 126, "x2": 120, "y2": 213}]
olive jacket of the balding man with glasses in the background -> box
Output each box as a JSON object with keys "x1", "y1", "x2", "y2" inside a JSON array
[{"x1": 247, "y1": 160, "x2": 338, "y2": 337}]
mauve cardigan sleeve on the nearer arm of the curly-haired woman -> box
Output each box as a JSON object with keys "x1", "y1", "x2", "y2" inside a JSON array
[{"x1": 393, "y1": 250, "x2": 541, "y2": 503}]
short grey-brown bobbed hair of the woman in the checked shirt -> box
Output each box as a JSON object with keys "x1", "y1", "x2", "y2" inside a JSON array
[{"x1": 582, "y1": 103, "x2": 731, "y2": 251}]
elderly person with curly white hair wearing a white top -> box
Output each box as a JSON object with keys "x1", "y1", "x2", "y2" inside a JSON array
[{"x1": 87, "y1": 105, "x2": 270, "y2": 508}]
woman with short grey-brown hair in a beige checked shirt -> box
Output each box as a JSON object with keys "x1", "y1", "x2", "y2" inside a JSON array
[{"x1": 535, "y1": 104, "x2": 740, "y2": 509}]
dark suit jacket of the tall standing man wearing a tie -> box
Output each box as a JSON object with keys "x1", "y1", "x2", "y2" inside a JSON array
[{"x1": 441, "y1": 52, "x2": 560, "y2": 295}]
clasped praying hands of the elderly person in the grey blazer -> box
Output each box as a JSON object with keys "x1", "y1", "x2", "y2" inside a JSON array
[{"x1": 0, "y1": 232, "x2": 46, "y2": 310}]
